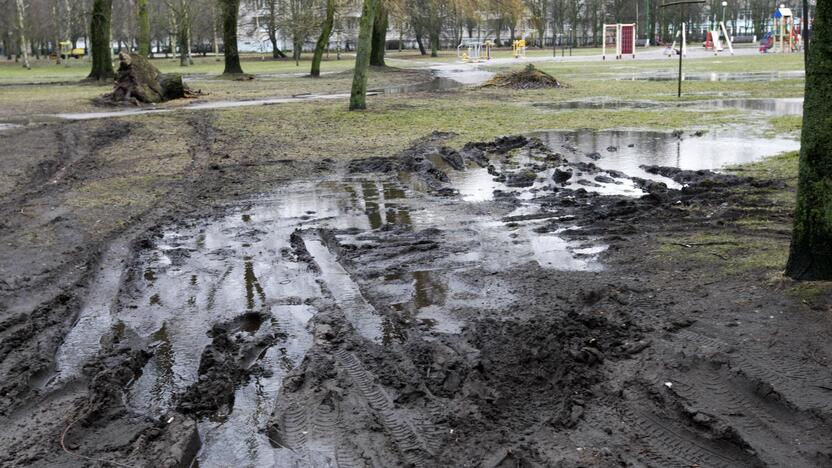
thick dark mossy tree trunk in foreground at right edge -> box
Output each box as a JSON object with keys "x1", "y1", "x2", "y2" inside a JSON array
[{"x1": 786, "y1": 0, "x2": 832, "y2": 280}]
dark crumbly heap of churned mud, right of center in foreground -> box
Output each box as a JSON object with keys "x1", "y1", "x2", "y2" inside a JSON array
[{"x1": 465, "y1": 313, "x2": 640, "y2": 427}]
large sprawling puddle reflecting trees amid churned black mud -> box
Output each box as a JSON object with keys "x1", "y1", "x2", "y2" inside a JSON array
[{"x1": 53, "y1": 126, "x2": 798, "y2": 466}]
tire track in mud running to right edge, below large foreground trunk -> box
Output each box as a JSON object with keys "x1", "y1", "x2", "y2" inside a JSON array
[{"x1": 676, "y1": 330, "x2": 832, "y2": 414}]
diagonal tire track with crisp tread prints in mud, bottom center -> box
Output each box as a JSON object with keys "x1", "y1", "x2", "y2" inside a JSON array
[{"x1": 335, "y1": 350, "x2": 438, "y2": 466}]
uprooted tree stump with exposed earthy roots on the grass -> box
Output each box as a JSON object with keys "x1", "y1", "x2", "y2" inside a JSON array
[{"x1": 100, "y1": 52, "x2": 199, "y2": 105}]
